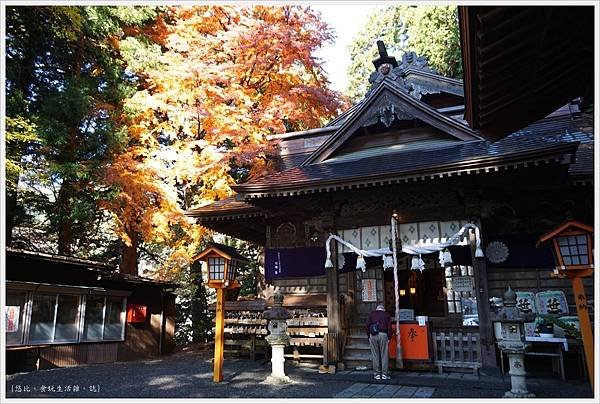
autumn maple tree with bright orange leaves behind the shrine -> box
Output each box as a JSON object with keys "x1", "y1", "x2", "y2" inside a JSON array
[{"x1": 104, "y1": 6, "x2": 345, "y2": 273}]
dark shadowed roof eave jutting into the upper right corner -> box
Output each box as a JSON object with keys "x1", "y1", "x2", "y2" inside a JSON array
[{"x1": 458, "y1": 5, "x2": 595, "y2": 140}]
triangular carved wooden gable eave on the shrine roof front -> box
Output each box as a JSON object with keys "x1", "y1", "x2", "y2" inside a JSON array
[{"x1": 301, "y1": 77, "x2": 481, "y2": 166}]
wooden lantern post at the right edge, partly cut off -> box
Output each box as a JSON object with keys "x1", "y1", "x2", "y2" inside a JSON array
[{"x1": 538, "y1": 221, "x2": 594, "y2": 391}]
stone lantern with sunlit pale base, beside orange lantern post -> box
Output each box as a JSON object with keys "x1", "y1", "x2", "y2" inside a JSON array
[{"x1": 263, "y1": 292, "x2": 291, "y2": 384}]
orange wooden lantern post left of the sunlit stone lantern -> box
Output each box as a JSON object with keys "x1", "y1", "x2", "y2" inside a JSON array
[{"x1": 194, "y1": 243, "x2": 249, "y2": 383}]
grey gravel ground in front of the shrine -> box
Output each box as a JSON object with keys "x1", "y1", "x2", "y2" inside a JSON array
[{"x1": 6, "y1": 352, "x2": 591, "y2": 398}]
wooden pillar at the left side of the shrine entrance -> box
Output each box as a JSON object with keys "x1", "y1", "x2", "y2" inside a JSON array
[{"x1": 323, "y1": 243, "x2": 342, "y2": 365}]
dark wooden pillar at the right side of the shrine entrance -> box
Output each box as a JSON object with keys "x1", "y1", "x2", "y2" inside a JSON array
[{"x1": 469, "y1": 227, "x2": 498, "y2": 368}]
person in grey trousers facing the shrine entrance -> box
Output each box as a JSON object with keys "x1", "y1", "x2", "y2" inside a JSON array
[{"x1": 367, "y1": 304, "x2": 392, "y2": 380}]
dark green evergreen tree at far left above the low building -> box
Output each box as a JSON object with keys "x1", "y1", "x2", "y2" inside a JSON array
[{"x1": 6, "y1": 6, "x2": 156, "y2": 256}]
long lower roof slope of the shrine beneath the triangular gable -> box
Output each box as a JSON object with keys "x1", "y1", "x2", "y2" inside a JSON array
[{"x1": 233, "y1": 114, "x2": 593, "y2": 197}]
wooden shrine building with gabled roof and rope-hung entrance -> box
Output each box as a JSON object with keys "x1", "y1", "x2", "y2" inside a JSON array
[{"x1": 187, "y1": 44, "x2": 594, "y2": 372}]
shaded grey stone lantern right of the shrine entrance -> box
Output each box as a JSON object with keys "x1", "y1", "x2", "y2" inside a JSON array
[{"x1": 492, "y1": 286, "x2": 535, "y2": 398}]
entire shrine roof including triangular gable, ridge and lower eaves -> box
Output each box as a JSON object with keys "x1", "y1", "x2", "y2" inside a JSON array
[{"x1": 187, "y1": 39, "x2": 594, "y2": 229}]
